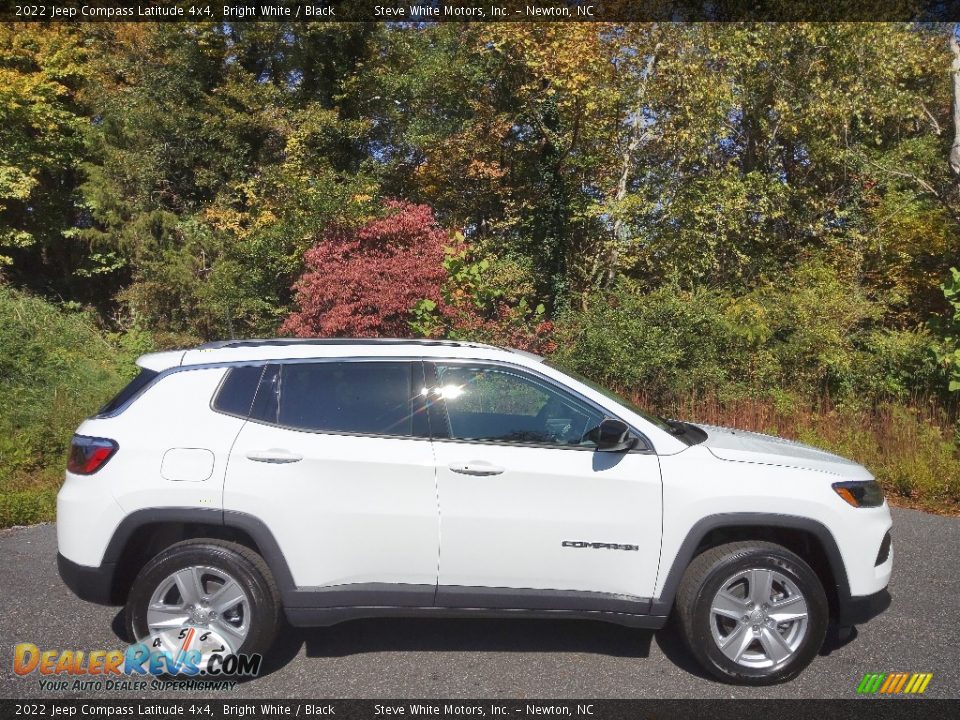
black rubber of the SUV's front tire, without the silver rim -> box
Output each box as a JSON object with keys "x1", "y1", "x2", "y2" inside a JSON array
[{"x1": 691, "y1": 549, "x2": 830, "y2": 685}]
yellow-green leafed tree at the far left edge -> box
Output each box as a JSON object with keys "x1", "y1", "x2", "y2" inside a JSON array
[{"x1": 0, "y1": 23, "x2": 88, "y2": 295}]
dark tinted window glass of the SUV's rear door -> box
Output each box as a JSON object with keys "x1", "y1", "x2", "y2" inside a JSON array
[{"x1": 252, "y1": 361, "x2": 426, "y2": 437}]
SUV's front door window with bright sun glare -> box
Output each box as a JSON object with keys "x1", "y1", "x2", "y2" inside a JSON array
[{"x1": 434, "y1": 364, "x2": 604, "y2": 447}]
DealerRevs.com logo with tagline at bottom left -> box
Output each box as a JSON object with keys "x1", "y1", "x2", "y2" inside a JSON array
[{"x1": 13, "y1": 640, "x2": 263, "y2": 691}]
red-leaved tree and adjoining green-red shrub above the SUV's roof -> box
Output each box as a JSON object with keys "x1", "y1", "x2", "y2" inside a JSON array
[{"x1": 281, "y1": 201, "x2": 553, "y2": 352}]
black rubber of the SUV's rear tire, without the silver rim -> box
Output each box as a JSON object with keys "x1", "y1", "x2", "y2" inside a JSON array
[{"x1": 126, "y1": 542, "x2": 278, "y2": 653}]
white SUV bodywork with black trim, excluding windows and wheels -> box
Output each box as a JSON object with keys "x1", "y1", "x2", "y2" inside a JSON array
[{"x1": 57, "y1": 341, "x2": 893, "y2": 640}]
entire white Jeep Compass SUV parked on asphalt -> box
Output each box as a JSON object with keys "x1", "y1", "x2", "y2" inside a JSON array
[{"x1": 57, "y1": 339, "x2": 893, "y2": 684}]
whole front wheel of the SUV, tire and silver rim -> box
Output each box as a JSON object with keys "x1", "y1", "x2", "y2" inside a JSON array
[{"x1": 676, "y1": 541, "x2": 830, "y2": 685}]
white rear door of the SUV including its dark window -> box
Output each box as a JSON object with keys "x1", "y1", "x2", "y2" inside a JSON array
[{"x1": 223, "y1": 359, "x2": 439, "y2": 606}]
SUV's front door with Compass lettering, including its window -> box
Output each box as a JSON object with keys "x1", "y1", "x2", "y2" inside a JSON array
[{"x1": 427, "y1": 361, "x2": 661, "y2": 613}]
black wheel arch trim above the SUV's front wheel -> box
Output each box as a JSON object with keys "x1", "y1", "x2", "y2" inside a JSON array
[{"x1": 650, "y1": 513, "x2": 850, "y2": 616}]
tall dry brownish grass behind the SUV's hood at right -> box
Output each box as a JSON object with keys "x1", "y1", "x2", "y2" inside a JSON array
[{"x1": 652, "y1": 396, "x2": 960, "y2": 514}]
